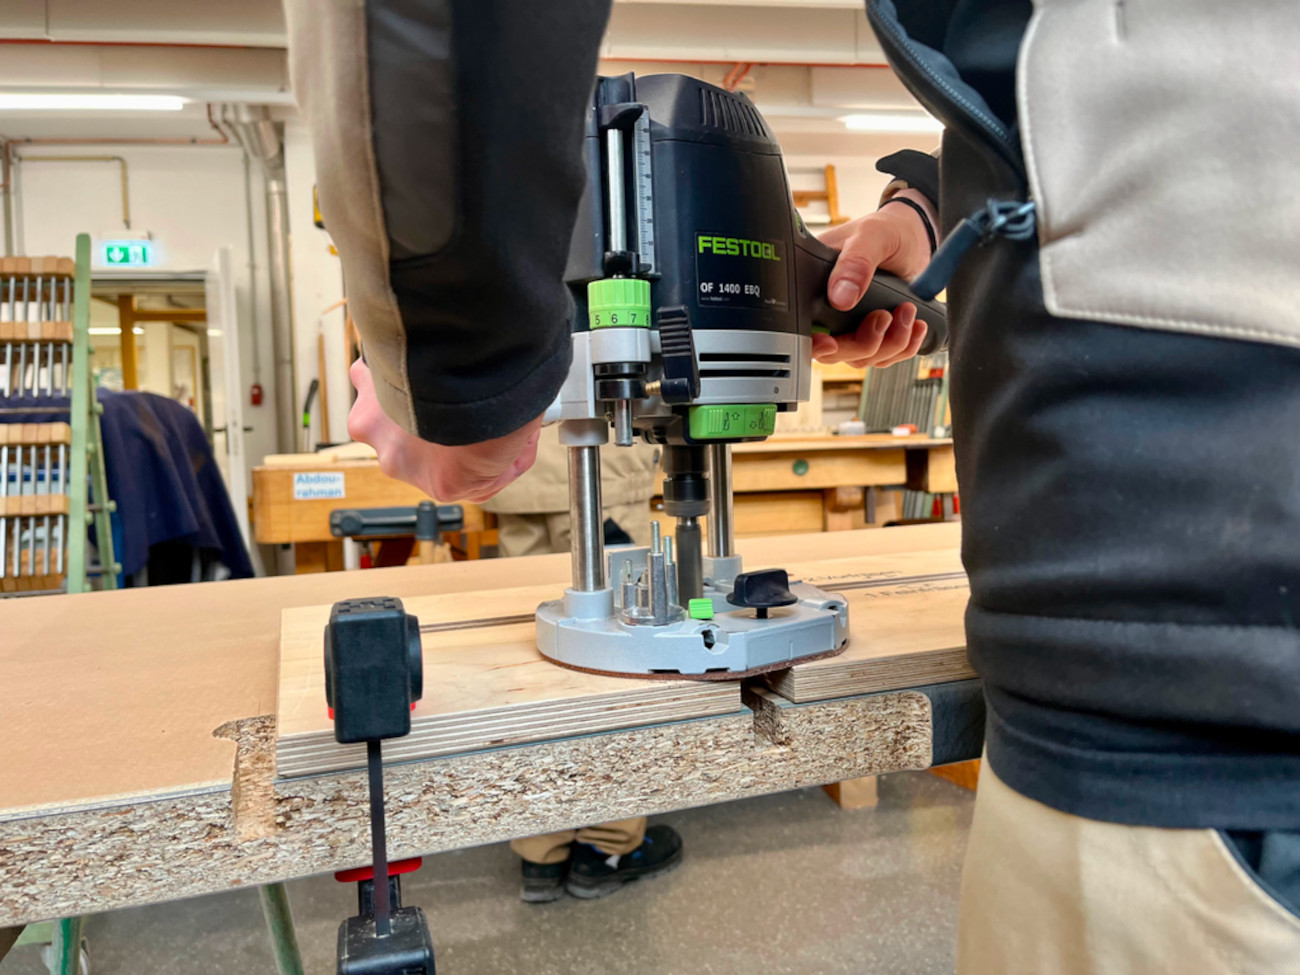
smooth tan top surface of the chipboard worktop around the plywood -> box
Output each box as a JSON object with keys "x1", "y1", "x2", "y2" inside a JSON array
[{"x1": 0, "y1": 524, "x2": 959, "y2": 816}]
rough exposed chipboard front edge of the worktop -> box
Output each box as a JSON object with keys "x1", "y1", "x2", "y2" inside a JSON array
[{"x1": 0, "y1": 692, "x2": 932, "y2": 927}]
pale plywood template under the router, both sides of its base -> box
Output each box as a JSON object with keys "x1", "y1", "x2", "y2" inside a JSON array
[{"x1": 276, "y1": 550, "x2": 970, "y2": 776}]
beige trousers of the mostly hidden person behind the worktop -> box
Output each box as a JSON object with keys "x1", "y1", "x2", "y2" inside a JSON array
[{"x1": 497, "y1": 501, "x2": 650, "y2": 863}]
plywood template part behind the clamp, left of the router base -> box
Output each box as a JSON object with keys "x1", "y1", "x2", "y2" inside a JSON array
[{"x1": 276, "y1": 586, "x2": 744, "y2": 776}]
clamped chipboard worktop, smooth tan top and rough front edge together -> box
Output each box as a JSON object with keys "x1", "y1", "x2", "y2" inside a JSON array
[{"x1": 0, "y1": 525, "x2": 970, "y2": 927}]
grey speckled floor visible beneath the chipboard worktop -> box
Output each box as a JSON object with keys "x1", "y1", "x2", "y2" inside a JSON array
[{"x1": 0, "y1": 772, "x2": 974, "y2": 975}]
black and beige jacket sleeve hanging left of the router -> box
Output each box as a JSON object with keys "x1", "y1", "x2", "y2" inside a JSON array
[{"x1": 285, "y1": 0, "x2": 610, "y2": 443}]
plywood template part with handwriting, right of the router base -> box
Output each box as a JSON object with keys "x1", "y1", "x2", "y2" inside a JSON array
[{"x1": 763, "y1": 551, "x2": 976, "y2": 703}]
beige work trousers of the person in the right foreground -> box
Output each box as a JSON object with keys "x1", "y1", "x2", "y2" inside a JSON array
[{"x1": 957, "y1": 761, "x2": 1300, "y2": 975}]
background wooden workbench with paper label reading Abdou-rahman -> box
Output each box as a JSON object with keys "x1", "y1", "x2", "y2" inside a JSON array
[{"x1": 252, "y1": 454, "x2": 486, "y2": 545}]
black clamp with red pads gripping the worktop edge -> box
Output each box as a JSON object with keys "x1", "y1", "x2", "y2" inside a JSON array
[{"x1": 325, "y1": 597, "x2": 434, "y2": 975}]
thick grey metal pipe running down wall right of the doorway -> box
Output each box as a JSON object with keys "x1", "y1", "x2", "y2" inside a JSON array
[{"x1": 221, "y1": 104, "x2": 298, "y2": 454}]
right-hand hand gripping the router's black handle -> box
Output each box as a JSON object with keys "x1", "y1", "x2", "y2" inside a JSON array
[{"x1": 813, "y1": 190, "x2": 932, "y2": 369}]
